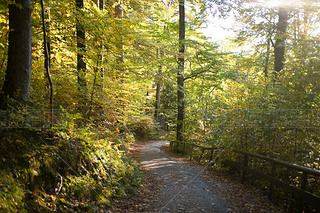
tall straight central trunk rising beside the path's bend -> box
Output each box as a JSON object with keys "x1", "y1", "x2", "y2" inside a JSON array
[{"x1": 177, "y1": 0, "x2": 186, "y2": 141}]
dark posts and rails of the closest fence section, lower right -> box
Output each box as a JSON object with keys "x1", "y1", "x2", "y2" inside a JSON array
[{"x1": 230, "y1": 151, "x2": 320, "y2": 212}]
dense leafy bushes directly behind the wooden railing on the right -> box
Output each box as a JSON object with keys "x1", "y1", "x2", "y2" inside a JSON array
[{"x1": 188, "y1": 48, "x2": 319, "y2": 168}]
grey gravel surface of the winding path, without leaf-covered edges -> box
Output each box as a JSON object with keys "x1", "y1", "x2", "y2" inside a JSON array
[{"x1": 141, "y1": 141, "x2": 228, "y2": 212}]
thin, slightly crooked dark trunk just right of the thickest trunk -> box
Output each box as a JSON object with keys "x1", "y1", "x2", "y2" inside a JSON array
[{"x1": 41, "y1": 0, "x2": 53, "y2": 125}]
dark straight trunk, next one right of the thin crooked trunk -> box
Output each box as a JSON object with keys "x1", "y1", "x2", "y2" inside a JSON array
[{"x1": 76, "y1": 0, "x2": 87, "y2": 91}]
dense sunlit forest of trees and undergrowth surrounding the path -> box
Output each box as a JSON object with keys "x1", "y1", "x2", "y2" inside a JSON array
[{"x1": 0, "y1": 0, "x2": 320, "y2": 212}]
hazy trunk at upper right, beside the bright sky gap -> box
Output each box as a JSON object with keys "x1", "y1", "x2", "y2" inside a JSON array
[{"x1": 274, "y1": 7, "x2": 289, "y2": 79}]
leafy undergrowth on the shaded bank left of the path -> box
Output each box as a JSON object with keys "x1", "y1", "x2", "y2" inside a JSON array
[{"x1": 0, "y1": 125, "x2": 143, "y2": 212}]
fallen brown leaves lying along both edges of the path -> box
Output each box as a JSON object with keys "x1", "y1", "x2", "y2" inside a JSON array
[{"x1": 109, "y1": 143, "x2": 283, "y2": 213}]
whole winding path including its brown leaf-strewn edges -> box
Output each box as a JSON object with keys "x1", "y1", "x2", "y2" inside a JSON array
[{"x1": 110, "y1": 141, "x2": 281, "y2": 212}]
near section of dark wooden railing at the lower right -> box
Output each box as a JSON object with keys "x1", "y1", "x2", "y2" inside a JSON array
[{"x1": 225, "y1": 151, "x2": 320, "y2": 212}]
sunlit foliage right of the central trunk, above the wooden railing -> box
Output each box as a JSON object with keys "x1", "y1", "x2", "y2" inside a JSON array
[{"x1": 175, "y1": 1, "x2": 320, "y2": 169}]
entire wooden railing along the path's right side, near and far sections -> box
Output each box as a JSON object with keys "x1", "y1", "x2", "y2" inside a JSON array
[{"x1": 170, "y1": 142, "x2": 320, "y2": 212}]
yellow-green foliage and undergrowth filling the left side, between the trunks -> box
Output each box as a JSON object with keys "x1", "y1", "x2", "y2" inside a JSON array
[{"x1": 0, "y1": 0, "x2": 225, "y2": 212}]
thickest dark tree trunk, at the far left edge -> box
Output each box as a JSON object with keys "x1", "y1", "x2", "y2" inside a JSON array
[{"x1": 0, "y1": 0, "x2": 32, "y2": 109}]
